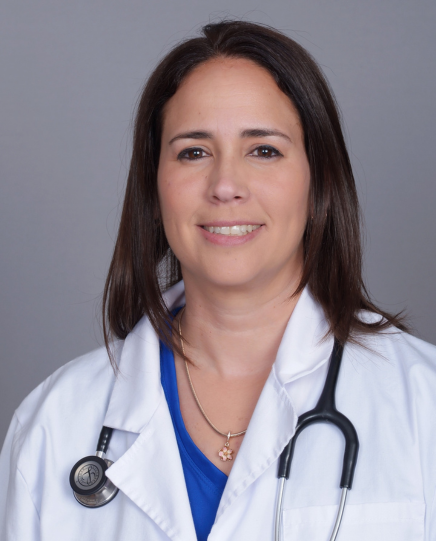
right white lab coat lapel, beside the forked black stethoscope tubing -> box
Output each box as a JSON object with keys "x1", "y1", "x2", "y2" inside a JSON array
[{"x1": 217, "y1": 288, "x2": 333, "y2": 521}]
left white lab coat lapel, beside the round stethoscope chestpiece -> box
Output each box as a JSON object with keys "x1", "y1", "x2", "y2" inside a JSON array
[{"x1": 104, "y1": 284, "x2": 196, "y2": 541}]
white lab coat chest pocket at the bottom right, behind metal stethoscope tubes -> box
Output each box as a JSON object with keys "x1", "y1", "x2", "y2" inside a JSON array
[{"x1": 283, "y1": 502, "x2": 425, "y2": 541}]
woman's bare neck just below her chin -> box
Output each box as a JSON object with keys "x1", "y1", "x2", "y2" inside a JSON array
[{"x1": 177, "y1": 277, "x2": 299, "y2": 379}]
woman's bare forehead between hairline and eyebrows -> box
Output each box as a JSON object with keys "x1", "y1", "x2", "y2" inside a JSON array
[{"x1": 163, "y1": 58, "x2": 299, "y2": 131}]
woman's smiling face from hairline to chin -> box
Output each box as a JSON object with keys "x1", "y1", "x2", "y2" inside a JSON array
[{"x1": 158, "y1": 59, "x2": 310, "y2": 294}]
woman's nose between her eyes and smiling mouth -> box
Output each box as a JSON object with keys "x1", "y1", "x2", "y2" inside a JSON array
[{"x1": 208, "y1": 156, "x2": 250, "y2": 204}]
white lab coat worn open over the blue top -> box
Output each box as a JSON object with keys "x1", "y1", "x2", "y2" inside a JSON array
[{"x1": 0, "y1": 283, "x2": 436, "y2": 541}]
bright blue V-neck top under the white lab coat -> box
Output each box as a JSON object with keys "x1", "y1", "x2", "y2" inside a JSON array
[{"x1": 160, "y1": 336, "x2": 227, "y2": 541}]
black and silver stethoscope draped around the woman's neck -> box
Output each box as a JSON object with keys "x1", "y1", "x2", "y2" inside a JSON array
[{"x1": 70, "y1": 340, "x2": 359, "y2": 541}]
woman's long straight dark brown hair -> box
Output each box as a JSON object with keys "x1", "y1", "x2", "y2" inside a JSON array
[{"x1": 103, "y1": 21, "x2": 405, "y2": 368}]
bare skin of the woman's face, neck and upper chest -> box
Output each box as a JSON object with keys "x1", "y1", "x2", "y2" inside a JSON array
[{"x1": 158, "y1": 59, "x2": 310, "y2": 474}]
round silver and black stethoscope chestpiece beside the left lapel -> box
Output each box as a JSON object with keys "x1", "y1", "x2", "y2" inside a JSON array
[{"x1": 70, "y1": 427, "x2": 118, "y2": 508}]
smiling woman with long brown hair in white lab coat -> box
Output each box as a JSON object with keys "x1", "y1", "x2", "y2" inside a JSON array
[{"x1": 0, "y1": 22, "x2": 436, "y2": 541}]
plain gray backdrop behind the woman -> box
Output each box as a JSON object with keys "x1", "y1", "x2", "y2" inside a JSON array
[{"x1": 0, "y1": 0, "x2": 436, "y2": 442}]
